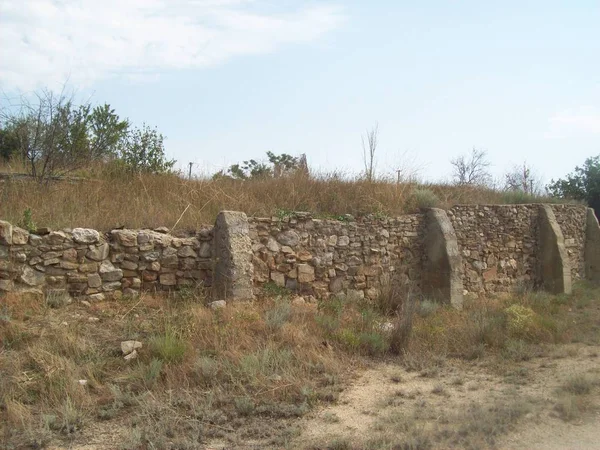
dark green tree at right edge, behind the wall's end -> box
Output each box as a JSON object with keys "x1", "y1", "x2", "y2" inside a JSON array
[{"x1": 547, "y1": 155, "x2": 600, "y2": 217}]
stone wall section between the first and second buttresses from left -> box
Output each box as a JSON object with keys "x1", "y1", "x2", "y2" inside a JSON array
[{"x1": 249, "y1": 213, "x2": 424, "y2": 298}]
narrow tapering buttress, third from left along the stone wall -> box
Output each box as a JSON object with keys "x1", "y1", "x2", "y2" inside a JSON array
[{"x1": 538, "y1": 205, "x2": 571, "y2": 294}]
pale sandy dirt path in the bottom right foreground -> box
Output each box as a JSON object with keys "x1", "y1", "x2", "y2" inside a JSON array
[{"x1": 296, "y1": 345, "x2": 600, "y2": 449}]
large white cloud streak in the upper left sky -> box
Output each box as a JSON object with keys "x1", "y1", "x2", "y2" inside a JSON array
[{"x1": 0, "y1": 0, "x2": 343, "y2": 91}]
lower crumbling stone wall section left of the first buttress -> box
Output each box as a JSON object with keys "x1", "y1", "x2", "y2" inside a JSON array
[{"x1": 0, "y1": 221, "x2": 213, "y2": 299}]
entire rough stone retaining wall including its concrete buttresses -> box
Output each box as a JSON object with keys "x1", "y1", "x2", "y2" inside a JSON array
[{"x1": 0, "y1": 204, "x2": 600, "y2": 307}]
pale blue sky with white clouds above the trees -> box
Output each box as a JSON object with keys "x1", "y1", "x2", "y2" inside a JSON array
[{"x1": 0, "y1": 0, "x2": 600, "y2": 182}]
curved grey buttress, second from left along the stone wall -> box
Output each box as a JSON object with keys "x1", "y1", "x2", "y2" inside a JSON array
[{"x1": 422, "y1": 208, "x2": 463, "y2": 308}]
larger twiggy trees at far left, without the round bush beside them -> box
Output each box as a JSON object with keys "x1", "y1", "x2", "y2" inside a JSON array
[{"x1": 0, "y1": 91, "x2": 129, "y2": 181}]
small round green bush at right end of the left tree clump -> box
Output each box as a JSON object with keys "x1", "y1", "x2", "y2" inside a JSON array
[{"x1": 118, "y1": 124, "x2": 175, "y2": 173}]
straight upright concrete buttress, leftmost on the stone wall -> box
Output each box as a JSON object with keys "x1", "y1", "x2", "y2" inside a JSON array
[{"x1": 213, "y1": 211, "x2": 254, "y2": 300}]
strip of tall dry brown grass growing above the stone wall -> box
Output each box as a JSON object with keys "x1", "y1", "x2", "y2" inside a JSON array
[{"x1": 0, "y1": 163, "x2": 564, "y2": 230}]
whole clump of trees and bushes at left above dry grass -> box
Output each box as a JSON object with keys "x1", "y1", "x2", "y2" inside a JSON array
[{"x1": 0, "y1": 91, "x2": 175, "y2": 181}]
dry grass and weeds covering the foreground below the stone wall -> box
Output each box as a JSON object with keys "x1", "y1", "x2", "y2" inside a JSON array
[{"x1": 0, "y1": 284, "x2": 600, "y2": 449}]
